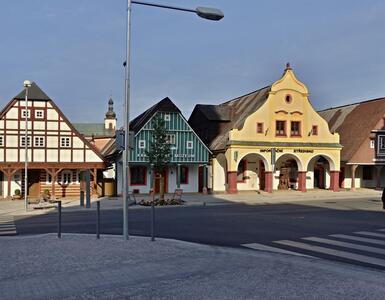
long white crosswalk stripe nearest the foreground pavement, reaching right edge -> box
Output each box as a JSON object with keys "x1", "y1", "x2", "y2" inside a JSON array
[{"x1": 274, "y1": 240, "x2": 385, "y2": 267}]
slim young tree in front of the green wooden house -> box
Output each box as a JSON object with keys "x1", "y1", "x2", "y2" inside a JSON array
[{"x1": 146, "y1": 115, "x2": 171, "y2": 200}]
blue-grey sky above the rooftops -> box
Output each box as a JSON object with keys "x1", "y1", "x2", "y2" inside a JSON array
[{"x1": 0, "y1": 0, "x2": 385, "y2": 124}]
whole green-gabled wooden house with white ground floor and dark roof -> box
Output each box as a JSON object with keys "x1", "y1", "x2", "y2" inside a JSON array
[{"x1": 116, "y1": 98, "x2": 210, "y2": 194}]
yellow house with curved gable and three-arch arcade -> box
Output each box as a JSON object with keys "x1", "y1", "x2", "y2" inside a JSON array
[{"x1": 189, "y1": 64, "x2": 342, "y2": 193}]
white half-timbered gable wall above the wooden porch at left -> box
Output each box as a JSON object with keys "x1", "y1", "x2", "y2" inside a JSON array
[{"x1": 0, "y1": 95, "x2": 104, "y2": 168}]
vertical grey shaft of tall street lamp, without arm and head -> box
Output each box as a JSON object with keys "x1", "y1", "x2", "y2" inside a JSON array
[{"x1": 122, "y1": 0, "x2": 131, "y2": 240}]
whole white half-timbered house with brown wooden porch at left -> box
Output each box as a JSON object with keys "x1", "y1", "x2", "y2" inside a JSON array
[{"x1": 0, "y1": 83, "x2": 105, "y2": 198}]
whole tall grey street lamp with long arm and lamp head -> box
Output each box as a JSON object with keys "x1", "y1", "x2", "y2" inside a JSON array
[{"x1": 122, "y1": 0, "x2": 224, "y2": 240}]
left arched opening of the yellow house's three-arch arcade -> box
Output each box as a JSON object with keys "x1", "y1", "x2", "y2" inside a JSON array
[{"x1": 237, "y1": 153, "x2": 266, "y2": 191}]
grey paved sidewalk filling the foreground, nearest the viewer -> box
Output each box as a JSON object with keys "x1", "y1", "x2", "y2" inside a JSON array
[{"x1": 0, "y1": 234, "x2": 385, "y2": 300}]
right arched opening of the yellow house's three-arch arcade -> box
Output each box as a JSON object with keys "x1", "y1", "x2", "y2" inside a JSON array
[{"x1": 307, "y1": 155, "x2": 334, "y2": 189}]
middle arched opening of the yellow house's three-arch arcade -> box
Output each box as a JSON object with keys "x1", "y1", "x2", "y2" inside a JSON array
[{"x1": 273, "y1": 154, "x2": 301, "y2": 190}]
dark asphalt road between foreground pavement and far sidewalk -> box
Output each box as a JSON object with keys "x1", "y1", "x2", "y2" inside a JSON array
[{"x1": 15, "y1": 200, "x2": 385, "y2": 270}]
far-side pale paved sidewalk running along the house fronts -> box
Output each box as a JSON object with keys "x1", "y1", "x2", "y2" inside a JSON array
[{"x1": 0, "y1": 189, "x2": 381, "y2": 216}]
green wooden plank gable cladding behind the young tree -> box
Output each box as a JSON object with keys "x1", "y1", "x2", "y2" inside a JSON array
[{"x1": 130, "y1": 112, "x2": 210, "y2": 163}]
